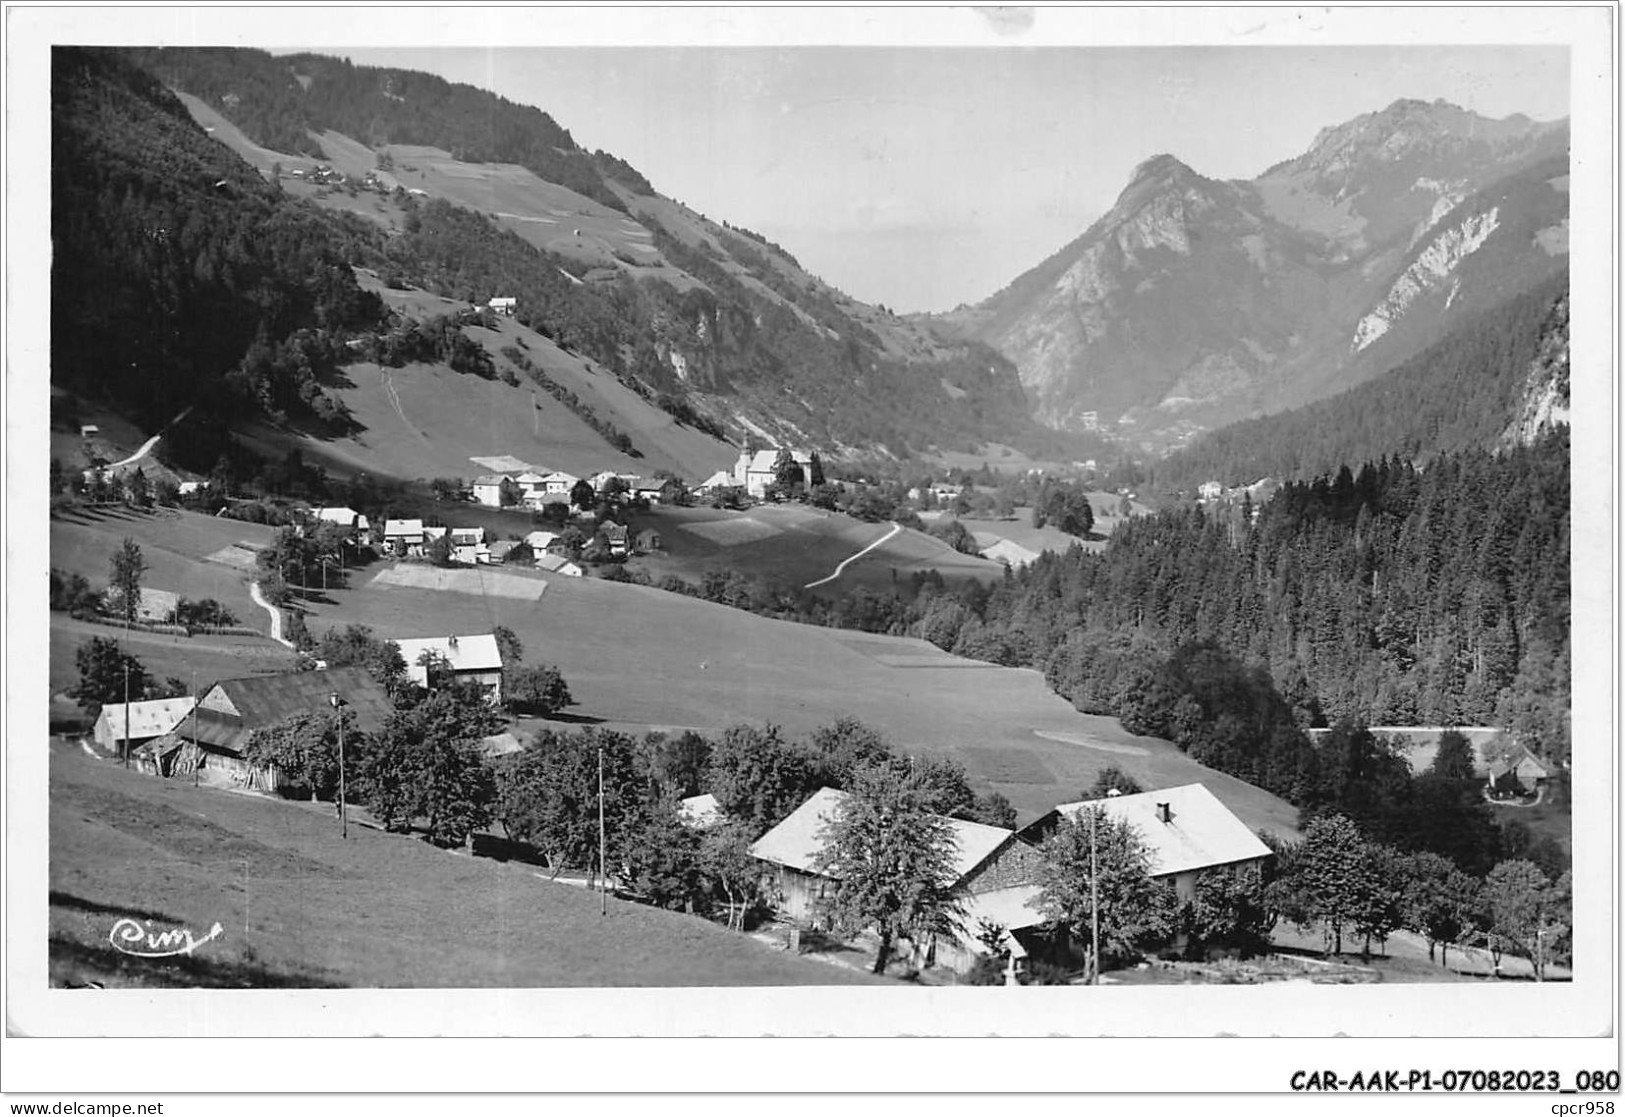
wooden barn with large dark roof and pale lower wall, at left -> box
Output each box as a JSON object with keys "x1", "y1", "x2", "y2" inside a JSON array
[{"x1": 145, "y1": 667, "x2": 395, "y2": 792}]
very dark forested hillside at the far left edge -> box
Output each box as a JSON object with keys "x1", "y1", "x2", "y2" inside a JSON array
[{"x1": 50, "y1": 47, "x2": 384, "y2": 429}]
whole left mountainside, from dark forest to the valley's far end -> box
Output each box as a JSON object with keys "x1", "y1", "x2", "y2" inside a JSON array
[{"x1": 52, "y1": 49, "x2": 1061, "y2": 471}]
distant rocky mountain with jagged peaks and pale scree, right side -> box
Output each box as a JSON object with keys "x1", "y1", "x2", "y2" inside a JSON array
[{"x1": 933, "y1": 93, "x2": 1568, "y2": 449}]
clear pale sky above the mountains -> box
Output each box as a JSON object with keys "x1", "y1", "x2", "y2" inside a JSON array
[{"x1": 333, "y1": 46, "x2": 1568, "y2": 312}]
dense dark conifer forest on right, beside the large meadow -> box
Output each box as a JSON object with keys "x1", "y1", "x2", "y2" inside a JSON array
[{"x1": 938, "y1": 428, "x2": 1570, "y2": 760}]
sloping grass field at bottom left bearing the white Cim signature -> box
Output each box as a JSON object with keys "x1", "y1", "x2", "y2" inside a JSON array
[{"x1": 49, "y1": 745, "x2": 874, "y2": 989}]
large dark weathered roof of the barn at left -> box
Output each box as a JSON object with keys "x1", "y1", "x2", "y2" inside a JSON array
[{"x1": 174, "y1": 667, "x2": 395, "y2": 753}]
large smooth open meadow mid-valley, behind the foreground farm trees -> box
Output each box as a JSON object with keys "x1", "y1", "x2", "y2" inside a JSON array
[{"x1": 299, "y1": 571, "x2": 1297, "y2": 834}]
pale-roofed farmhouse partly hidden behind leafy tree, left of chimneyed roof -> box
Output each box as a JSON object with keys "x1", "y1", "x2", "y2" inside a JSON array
[{"x1": 751, "y1": 787, "x2": 1040, "y2": 972}]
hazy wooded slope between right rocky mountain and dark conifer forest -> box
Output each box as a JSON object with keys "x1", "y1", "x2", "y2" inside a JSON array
[{"x1": 1154, "y1": 275, "x2": 1568, "y2": 493}]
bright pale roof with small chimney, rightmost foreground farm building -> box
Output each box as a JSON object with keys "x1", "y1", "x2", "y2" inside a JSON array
[{"x1": 1055, "y1": 784, "x2": 1269, "y2": 876}]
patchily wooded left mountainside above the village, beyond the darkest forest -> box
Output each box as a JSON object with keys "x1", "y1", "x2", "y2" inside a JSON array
[{"x1": 104, "y1": 49, "x2": 1076, "y2": 457}]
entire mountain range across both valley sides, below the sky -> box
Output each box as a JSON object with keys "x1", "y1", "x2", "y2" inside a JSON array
[{"x1": 52, "y1": 49, "x2": 1568, "y2": 481}]
